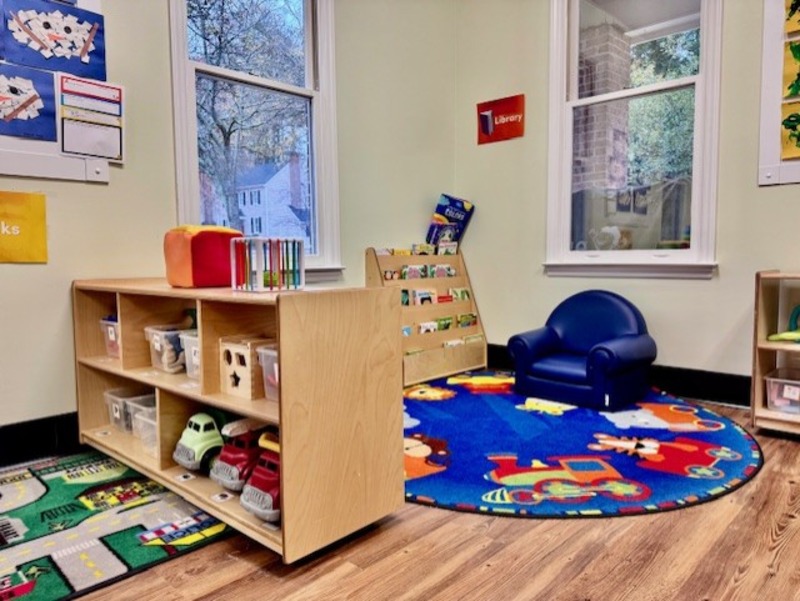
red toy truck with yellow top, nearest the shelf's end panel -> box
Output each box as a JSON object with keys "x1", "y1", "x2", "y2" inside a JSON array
[{"x1": 239, "y1": 432, "x2": 281, "y2": 522}]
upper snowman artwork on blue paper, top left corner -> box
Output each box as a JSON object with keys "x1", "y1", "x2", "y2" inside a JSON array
[{"x1": 0, "y1": 0, "x2": 106, "y2": 80}]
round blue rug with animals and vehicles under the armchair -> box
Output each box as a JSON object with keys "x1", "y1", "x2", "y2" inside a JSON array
[{"x1": 404, "y1": 372, "x2": 762, "y2": 518}]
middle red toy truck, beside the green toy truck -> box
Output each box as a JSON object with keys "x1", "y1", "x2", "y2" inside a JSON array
[{"x1": 209, "y1": 418, "x2": 266, "y2": 491}]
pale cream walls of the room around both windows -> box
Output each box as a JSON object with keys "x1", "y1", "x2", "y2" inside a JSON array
[{"x1": 0, "y1": 0, "x2": 800, "y2": 425}]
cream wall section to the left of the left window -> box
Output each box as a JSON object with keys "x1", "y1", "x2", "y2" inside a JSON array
[{"x1": 0, "y1": 0, "x2": 176, "y2": 425}]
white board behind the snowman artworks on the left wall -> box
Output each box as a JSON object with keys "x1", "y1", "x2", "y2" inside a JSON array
[{"x1": 0, "y1": 0, "x2": 109, "y2": 183}]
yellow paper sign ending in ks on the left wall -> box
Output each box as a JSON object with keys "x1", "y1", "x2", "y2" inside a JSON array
[{"x1": 0, "y1": 191, "x2": 47, "y2": 263}]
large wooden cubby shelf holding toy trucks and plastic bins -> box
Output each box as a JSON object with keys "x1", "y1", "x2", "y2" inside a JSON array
[{"x1": 73, "y1": 279, "x2": 404, "y2": 563}]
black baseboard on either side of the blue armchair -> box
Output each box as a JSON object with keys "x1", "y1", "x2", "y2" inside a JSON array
[{"x1": 488, "y1": 344, "x2": 751, "y2": 407}]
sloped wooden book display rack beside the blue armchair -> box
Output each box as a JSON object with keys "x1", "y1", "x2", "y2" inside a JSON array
[{"x1": 365, "y1": 248, "x2": 487, "y2": 386}]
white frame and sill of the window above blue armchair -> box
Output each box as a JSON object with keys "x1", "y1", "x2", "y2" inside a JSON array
[{"x1": 544, "y1": 0, "x2": 722, "y2": 279}]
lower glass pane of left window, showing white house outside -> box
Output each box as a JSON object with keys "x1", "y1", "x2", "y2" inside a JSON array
[{"x1": 196, "y1": 76, "x2": 317, "y2": 254}]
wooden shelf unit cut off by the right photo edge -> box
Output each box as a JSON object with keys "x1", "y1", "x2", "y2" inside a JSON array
[{"x1": 750, "y1": 271, "x2": 800, "y2": 434}]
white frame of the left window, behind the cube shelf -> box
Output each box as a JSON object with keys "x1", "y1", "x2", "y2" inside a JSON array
[{"x1": 169, "y1": 0, "x2": 343, "y2": 276}]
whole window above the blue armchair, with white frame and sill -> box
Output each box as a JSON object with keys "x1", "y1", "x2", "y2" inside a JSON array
[{"x1": 546, "y1": 0, "x2": 722, "y2": 278}]
